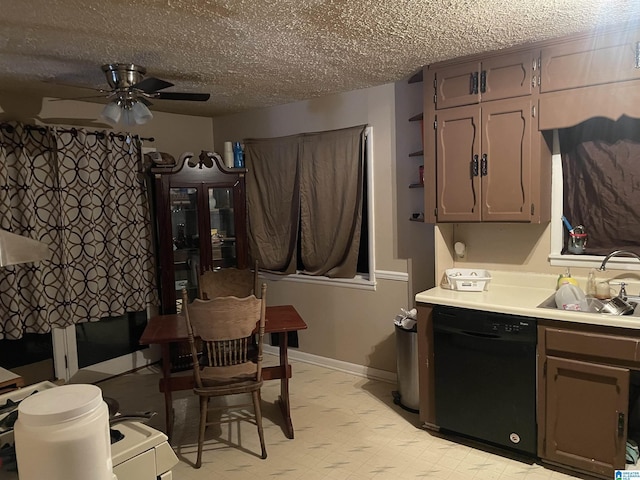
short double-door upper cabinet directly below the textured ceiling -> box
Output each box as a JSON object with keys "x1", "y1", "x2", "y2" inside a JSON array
[{"x1": 434, "y1": 51, "x2": 538, "y2": 110}]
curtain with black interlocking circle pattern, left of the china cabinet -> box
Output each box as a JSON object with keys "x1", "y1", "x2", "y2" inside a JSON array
[{"x1": 0, "y1": 125, "x2": 158, "y2": 338}]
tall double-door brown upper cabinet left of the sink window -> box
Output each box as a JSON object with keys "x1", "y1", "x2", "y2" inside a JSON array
[{"x1": 435, "y1": 98, "x2": 550, "y2": 223}]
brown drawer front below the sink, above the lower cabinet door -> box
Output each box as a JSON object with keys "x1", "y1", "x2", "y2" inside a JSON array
[{"x1": 545, "y1": 328, "x2": 640, "y2": 362}]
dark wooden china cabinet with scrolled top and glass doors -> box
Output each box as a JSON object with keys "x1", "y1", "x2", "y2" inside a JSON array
[{"x1": 150, "y1": 151, "x2": 249, "y2": 314}]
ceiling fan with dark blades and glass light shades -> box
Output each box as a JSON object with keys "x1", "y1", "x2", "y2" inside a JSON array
[{"x1": 87, "y1": 63, "x2": 211, "y2": 126}]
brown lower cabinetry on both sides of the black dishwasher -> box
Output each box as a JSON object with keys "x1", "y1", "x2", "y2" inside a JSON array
[{"x1": 417, "y1": 304, "x2": 640, "y2": 479}]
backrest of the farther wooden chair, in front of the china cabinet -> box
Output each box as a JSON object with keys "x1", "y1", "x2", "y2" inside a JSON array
[{"x1": 198, "y1": 262, "x2": 259, "y2": 300}]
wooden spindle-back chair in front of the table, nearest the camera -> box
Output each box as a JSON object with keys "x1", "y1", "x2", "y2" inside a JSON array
[{"x1": 182, "y1": 284, "x2": 267, "y2": 468}]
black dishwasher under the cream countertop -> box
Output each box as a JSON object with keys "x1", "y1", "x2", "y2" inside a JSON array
[{"x1": 433, "y1": 306, "x2": 537, "y2": 455}]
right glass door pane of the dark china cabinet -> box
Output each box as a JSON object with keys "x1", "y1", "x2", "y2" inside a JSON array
[{"x1": 208, "y1": 187, "x2": 238, "y2": 268}]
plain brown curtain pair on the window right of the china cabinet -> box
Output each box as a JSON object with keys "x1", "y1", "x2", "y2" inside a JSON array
[{"x1": 245, "y1": 126, "x2": 366, "y2": 278}]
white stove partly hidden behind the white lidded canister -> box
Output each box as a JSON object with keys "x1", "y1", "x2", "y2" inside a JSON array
[{"x1": 0, "y1": 382, "x2": 178, "y2": 480}]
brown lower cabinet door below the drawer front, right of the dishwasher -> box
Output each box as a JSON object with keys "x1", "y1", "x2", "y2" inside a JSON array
[{"x1": 540, "y1": 356, "x2": 630, "y2": 478}]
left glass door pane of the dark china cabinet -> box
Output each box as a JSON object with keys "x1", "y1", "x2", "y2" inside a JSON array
[{"x1": 169, "y1": 188, "x2": 200, "y2": 304}]
